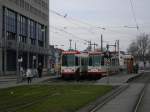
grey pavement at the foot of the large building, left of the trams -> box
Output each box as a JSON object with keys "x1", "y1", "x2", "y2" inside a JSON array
[{"x1": 0, "y1": 76, "x2": 58, "y2": 88}]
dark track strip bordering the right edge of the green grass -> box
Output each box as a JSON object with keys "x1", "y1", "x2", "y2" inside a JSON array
[{"x1": 76, "y1": 84, "x2": 129, "y2": 112}]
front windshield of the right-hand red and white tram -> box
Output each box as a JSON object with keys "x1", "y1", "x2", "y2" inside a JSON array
[{"x1": 89, "y1": 55, "x2": 101, "y2": 66}]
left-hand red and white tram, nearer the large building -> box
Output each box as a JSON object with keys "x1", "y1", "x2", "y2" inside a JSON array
[{"x1": 61, "y1": 51, "x2": 88, "y2": 79}]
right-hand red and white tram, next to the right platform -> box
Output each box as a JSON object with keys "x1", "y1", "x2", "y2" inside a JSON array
[{"x1": 88, "y1": 52, "x2": 119, "y2": 78}]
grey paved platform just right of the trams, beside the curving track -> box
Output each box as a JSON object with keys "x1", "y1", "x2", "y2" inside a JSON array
[{"x1": 95, "y1": 73, "x2": 140, "y2": 85}]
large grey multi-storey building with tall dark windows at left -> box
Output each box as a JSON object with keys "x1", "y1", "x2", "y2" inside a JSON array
[{"x1": 0, "y1": 0, "x2": 49, "y2": 75}]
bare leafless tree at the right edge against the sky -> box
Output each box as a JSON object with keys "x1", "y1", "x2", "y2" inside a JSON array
[{"x1": 128, "y1": 33, "x2": 150, "y2": 63}]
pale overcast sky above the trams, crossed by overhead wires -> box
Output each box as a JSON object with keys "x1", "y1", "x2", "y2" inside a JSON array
[{"x1": 50, "y1": 0, "x2": 150, "y2": 50}]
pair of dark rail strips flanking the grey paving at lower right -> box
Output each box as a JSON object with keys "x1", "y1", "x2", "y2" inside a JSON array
[{"x1": 88, "y1": 73, "x2": 150, "y2": 112}]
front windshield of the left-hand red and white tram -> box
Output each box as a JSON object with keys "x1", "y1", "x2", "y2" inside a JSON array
[{"x1": 62, "y1": 54, "x2": 75, "y2": 66}]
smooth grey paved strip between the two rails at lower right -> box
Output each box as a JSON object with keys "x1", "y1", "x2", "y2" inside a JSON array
[{"x1": 96, "y1": 84, "x2": 144, "y2": 112}]
